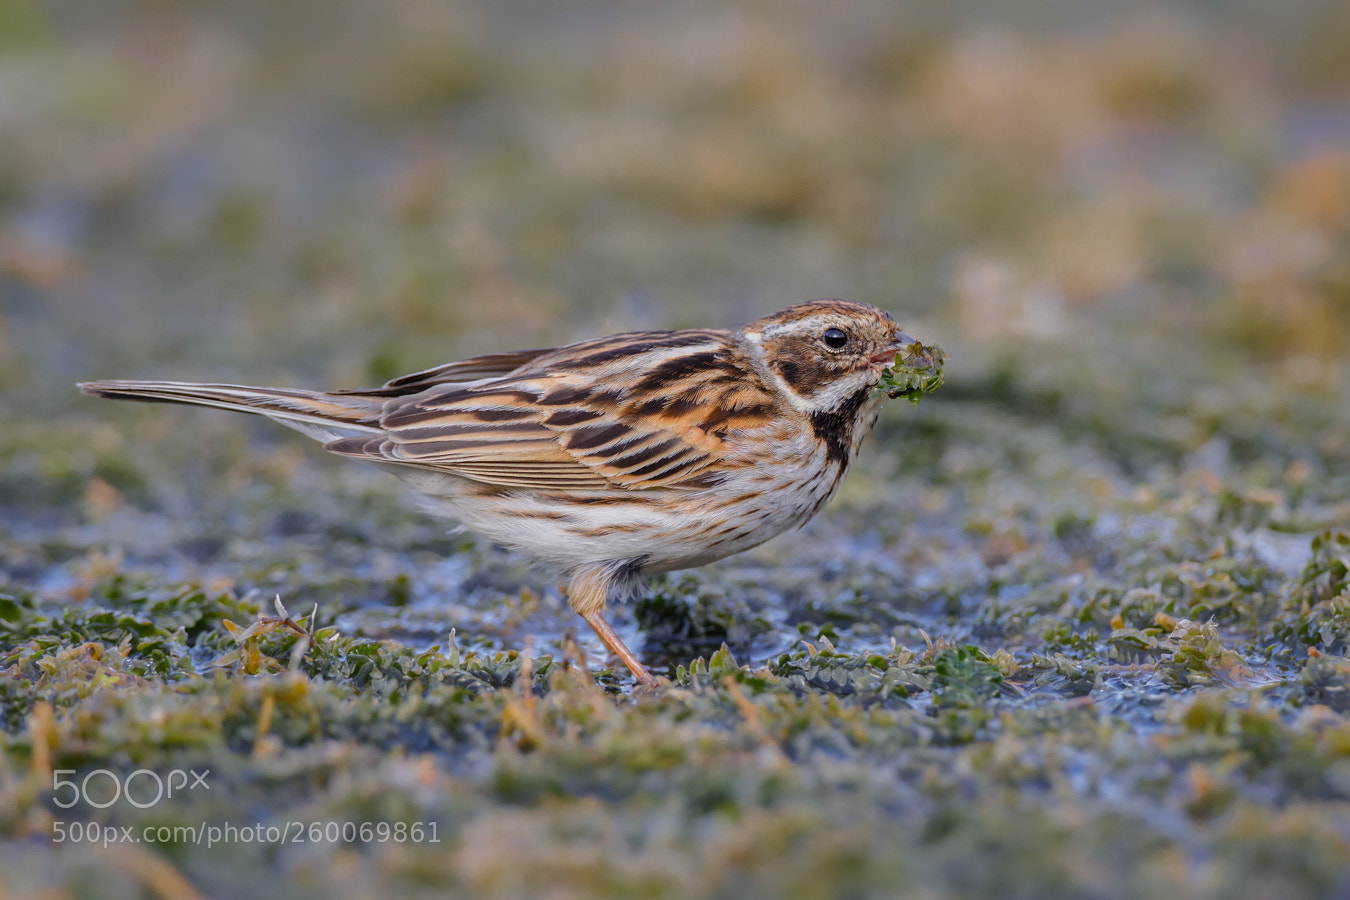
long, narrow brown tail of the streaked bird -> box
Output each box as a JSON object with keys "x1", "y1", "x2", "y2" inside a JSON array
[{"x1": 80, "y1": 381, "x2": 383, "y2": 441}]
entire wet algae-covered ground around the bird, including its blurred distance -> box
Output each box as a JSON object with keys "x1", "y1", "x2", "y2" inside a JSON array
[{"x1": 0, "y1": 0, "x2": 1350, "y2": 897}]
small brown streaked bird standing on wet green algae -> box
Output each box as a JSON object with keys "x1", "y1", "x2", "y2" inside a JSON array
[{"x1": 80, "y1": 300, "x2": 914, "y2": 684}]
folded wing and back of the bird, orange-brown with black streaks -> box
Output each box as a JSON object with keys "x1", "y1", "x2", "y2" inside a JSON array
[{"x1": 328, "y1": 332, "x2": 775, "y2": 490}]
